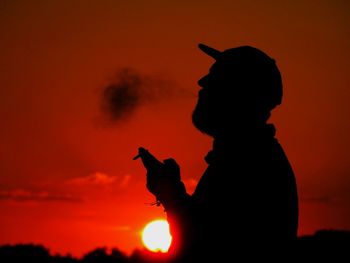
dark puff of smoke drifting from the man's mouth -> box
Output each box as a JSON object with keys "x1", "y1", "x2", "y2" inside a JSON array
[{"x1": 101, "y1": 68, "x2": 188, "y2": 124}]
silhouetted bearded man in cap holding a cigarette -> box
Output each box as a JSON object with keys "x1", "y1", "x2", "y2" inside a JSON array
[{"x1": 135, "y1": 44, "x2": 298, "y2": 262}]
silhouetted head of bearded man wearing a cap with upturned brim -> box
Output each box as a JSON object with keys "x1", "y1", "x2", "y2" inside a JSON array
[{"x1": 192, "y1": 44, "x2": 283, "y2": 136}]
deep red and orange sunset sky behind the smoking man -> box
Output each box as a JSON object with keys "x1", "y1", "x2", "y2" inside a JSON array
[{"x1": 0, "y1": 0, "x2": 350, "y2": 255}]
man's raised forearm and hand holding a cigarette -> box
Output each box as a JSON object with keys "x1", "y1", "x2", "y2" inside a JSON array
[{"x1": 135, "y1": 148, "x2": 197, "y2": 255}]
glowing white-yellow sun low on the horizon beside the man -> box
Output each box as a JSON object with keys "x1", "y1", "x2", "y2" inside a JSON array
[{"x1": 142, "y1": 219, "x2": 172, "y2": 253}]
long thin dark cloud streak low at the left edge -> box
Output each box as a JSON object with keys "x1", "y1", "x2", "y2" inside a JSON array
[{"x1": 0, "y1": 189, "x2": 83, "y2": 203}]
